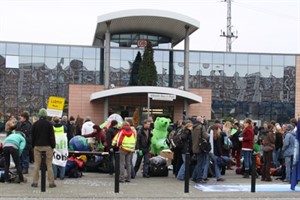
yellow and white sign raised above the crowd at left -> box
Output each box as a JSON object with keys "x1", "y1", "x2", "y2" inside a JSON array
[{"x1": 47, "y1": 96, "x2": 65, "y2": 117}]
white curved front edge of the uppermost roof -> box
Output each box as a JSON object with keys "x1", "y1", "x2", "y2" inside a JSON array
[{"x1": 97, "y1": 9, "x2": 200, "y2": 28}]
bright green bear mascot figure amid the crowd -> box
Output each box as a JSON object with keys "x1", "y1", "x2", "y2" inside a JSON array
[{"x1": 151, "y1": 117, "x2": 171, "y2": 156}]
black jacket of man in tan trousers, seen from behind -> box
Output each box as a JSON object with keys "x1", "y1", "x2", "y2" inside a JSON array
[{"x1": 31, "y1": 118, "x2": 56, "y2": 149}]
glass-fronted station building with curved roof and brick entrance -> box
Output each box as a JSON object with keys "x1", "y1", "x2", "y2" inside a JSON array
[{"x1": 0, "y1": 10, "x2": 300, "y2": 123}]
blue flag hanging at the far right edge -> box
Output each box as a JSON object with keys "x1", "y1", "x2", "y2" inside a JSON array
[{"x1": 291, "y1": 118, "x2": 300, "y2": 190}]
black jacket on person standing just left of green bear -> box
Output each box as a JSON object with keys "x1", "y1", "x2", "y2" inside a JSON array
[{"x1": 135, "y1": 127, "x2": 152, "y2": 152}]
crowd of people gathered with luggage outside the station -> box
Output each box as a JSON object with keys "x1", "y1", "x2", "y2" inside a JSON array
[{"x1": 3, "y1": 111, "x2": 297, "y2": 188}]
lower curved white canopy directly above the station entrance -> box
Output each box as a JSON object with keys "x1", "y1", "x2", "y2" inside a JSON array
[{"x1": 90, "y1": 86, "x2": 202, "y2": 103}]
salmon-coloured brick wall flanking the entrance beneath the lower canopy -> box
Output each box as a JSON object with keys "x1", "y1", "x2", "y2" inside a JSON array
[{"x1": 69, "y1": 84, "x2": 211, "y2": 124}]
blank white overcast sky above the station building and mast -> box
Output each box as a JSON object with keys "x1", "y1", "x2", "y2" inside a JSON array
[{"x1": 0, "y1": 0, "x2": 300, "y2": 54}]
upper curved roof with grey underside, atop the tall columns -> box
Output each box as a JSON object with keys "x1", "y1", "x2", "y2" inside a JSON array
[{"x1": 93, "y1": 9, "x2": 200, "y2": 46}]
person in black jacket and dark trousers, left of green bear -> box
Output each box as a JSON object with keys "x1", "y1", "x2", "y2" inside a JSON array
[{"x1": 134, "y1": 120, "x2": 152, "y2": 178}]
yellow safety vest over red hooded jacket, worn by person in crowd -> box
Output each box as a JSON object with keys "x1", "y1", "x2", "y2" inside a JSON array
[{"x1": 112, "y1": 126, "x2": 136, "y2": 152}]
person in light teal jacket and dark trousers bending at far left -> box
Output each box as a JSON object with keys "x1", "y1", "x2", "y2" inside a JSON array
[{"x1": 3, "y1": 122, "x2": 26, "y2": 183}]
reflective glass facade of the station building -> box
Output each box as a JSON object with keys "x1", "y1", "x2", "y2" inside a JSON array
[{"x1": 0, "y1": 40, "x2": 296, "y2": 122}]
